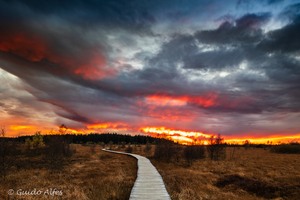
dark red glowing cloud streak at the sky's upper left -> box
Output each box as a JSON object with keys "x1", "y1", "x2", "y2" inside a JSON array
[{"x1": 0, "y1": 32, "x2": 116, "y2": 79}]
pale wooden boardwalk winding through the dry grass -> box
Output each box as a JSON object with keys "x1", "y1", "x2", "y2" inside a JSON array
[{"x1": 103, "y1": 149, "x2": 171, "y2": 200}]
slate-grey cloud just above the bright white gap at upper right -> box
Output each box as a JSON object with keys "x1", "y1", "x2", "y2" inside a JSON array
[{"x1": 139, "y1": 13, "x2": 270, "y2": 72}]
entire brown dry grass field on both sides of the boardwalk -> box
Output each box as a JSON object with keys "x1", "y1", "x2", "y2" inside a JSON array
[{"x1": 0, "y1": 141, "x2": 300, "y2": 200}]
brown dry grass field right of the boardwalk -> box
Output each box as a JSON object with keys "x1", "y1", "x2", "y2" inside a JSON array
[{"x1": 119, "y1": 146, "x2": 300, "y2": 200}]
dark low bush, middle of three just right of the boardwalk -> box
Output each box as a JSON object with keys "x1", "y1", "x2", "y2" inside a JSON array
[{"x1": 184, "y1": 145, "x2": 205, "y2": 165}]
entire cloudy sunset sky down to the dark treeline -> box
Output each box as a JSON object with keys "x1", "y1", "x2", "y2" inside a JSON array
[{"x1": 0, "y1": 0, "x2": 300, "y2": 144}]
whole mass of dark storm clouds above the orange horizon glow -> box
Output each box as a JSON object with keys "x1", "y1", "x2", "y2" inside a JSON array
[{"x1": 0, "y1": 0, "x2": 300, "y2": 136}]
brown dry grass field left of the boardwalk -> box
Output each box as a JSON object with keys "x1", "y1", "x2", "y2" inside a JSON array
[{"x1": 0, "y1": 145, "x2": 137, "y2": 200}]
